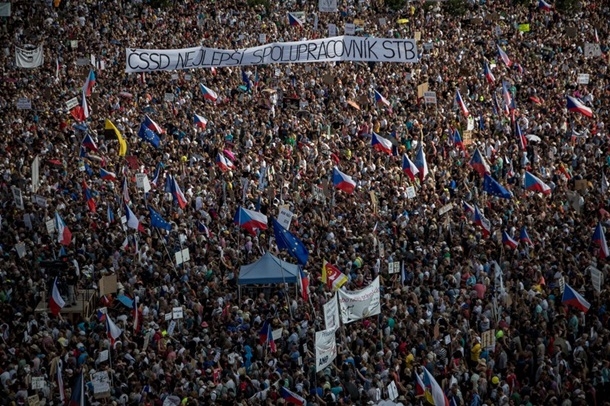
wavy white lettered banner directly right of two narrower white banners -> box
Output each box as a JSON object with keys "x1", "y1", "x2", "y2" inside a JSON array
[{"x1": 338, "y1": 277, "x2": 381, "y2": 324}]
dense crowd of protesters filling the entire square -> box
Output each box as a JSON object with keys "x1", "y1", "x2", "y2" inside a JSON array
[{"x1": 0, "y1": 0, "x2": 610, "y2": 406}]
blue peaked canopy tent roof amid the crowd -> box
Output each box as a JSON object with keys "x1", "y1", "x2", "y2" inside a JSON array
[{"x1": 238, "y1": 252, "x2": 299, "y2": 285}]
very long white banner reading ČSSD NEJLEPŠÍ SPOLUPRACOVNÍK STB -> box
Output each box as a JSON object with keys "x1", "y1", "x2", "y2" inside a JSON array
[{"x1": 125, "y1": 36, "x2": 417, "y2": 73}]
